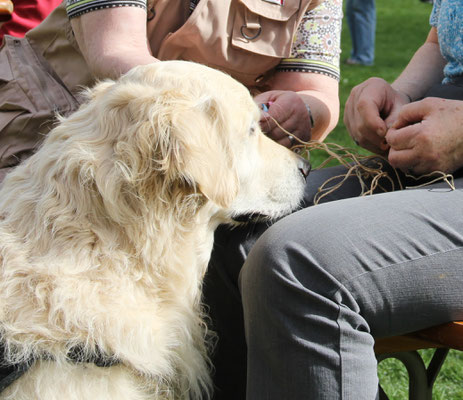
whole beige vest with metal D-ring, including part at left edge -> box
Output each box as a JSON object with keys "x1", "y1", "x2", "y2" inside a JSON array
[{"x1": 0, "y1": 0, "x2": 319, "y2": 181}]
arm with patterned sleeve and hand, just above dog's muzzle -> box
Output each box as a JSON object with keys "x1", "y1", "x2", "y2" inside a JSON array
[{"x1": 257, "y1": 0, "x2": 342, "y2": 147}]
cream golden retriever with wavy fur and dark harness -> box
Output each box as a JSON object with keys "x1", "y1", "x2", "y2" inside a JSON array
[{"x1": 0, "y1": 61, "x2": 309, "y2": 400}]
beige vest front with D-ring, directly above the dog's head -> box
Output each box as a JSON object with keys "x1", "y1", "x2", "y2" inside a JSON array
[{"x1": 148, "y1": 0, "x2": 319, "y2": 87}]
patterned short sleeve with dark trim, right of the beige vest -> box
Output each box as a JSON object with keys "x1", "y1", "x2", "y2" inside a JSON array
[{"x1": 276, "y1": 0, "x2": 342, "y2": 80}]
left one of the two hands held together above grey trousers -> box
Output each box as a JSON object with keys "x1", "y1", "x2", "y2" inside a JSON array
[{"x1": 344, "y1": 78, "x2": 410, "y2": 154}]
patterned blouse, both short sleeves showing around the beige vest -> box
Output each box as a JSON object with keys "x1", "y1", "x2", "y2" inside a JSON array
[{"x1": 66, "y1": 0, "x2": 342, "y2": 80}]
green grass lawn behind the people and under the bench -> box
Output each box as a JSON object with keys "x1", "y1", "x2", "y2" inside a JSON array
[{"x1": 324, "y1": 0, "x2": 463, "y2": 400}]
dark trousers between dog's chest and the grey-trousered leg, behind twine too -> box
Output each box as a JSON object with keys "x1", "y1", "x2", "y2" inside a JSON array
[{"x1": 203, "y1": 166, "x2": 460, "y2": 400}]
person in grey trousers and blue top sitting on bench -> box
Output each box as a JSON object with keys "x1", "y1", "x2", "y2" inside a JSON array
[{"x1": 205, "y1": 0, "x2": 463, "y2": 400}]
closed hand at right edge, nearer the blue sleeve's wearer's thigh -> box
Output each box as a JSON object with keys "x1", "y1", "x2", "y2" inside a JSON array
[{"x1": 386, "y1": 97, "x2": 463, "y2": 175}]
